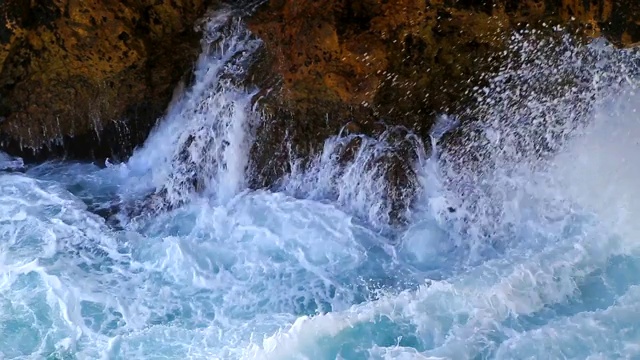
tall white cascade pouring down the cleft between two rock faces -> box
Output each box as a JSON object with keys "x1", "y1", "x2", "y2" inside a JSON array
[{"x1": 122, "y1": 10, "x2": 261, "y2": 207}]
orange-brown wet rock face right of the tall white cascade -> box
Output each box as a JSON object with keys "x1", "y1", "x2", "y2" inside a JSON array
[{"x1": 248, "y1": 0, "x2": 640, "y2": 225}]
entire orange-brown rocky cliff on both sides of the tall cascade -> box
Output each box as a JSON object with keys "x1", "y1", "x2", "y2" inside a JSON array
[{"x1": 0, "y1": 0, "x2": 640, "y2": 224}]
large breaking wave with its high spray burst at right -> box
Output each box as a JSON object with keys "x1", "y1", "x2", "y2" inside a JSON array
[{"x1": 247, "y1": 29, "x2": 640, "y2": 359}]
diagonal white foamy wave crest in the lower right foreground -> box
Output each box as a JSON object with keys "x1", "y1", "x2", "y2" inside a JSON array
[{"x1": 247, "y1": 212, "x2": 624, "y2": 359}]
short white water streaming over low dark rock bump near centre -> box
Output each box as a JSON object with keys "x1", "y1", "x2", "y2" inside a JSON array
[{"x1": 280, "y1": 127, "x2": 426, "y2": 229}]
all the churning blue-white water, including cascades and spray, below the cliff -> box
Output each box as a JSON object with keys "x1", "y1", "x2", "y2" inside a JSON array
[{"x1": 0, "y1": 5, "x2": 640, "y2": 359}]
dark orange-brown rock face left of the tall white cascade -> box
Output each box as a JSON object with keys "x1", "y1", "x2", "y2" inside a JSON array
[{"x1": 0, "y1": 0, "x2": 211, "y2": 158}]
